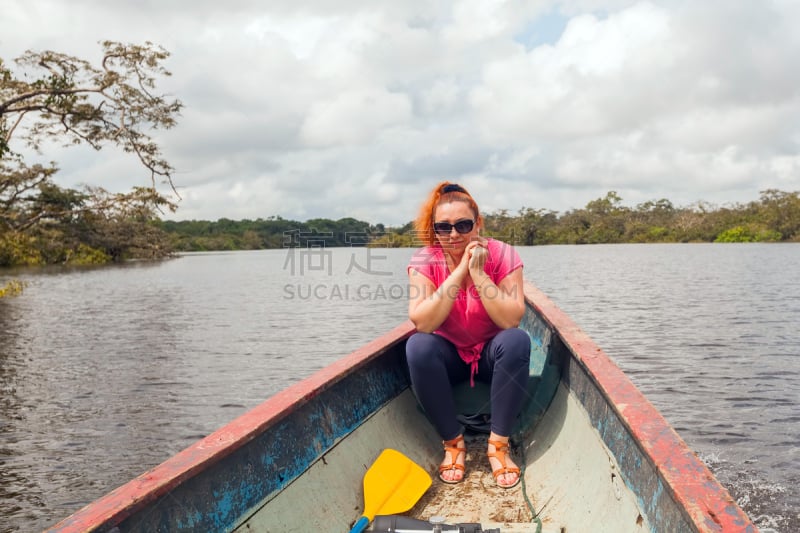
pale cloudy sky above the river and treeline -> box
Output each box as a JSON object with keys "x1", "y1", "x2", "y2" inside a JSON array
[{"x1": 0, "y1": 0, "x2": 800, "y2": 225}]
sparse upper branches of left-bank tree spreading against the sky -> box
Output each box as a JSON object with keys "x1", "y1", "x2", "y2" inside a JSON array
[{"x1": 0, "y1": 41, "x2": 182, "y2": 229}]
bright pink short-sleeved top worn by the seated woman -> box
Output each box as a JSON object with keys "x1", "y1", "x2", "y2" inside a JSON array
[{"x1": 408, "y1": 239, "x2": 522, "y2": 380}]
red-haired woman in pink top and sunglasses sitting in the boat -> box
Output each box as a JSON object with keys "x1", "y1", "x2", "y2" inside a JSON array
[{"x1": 406, "y1": 181, "x2": 530, "y2": 488}]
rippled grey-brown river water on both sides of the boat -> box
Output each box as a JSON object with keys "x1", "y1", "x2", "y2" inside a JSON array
[{"x1": 0, "y1": 244, "x2": 800, "y2": 533}]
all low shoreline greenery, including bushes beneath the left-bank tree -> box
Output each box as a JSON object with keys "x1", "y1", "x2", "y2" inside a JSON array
[{"x1": 0, "y1": 184, "x2": 800, "y2": 266}]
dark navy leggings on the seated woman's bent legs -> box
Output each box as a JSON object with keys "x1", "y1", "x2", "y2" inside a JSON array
[{"x1": 406, "y1": 328, "x2": 531, "y2": 440}]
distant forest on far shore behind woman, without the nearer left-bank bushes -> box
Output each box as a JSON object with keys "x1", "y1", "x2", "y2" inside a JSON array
[{"x1": 161, "y1": 189, "x2": 800, "y2": 251}]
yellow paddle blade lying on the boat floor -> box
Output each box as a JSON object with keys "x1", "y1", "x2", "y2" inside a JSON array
[{"x1": 364, "y1": 448, "x2": 433, "y2": 522}]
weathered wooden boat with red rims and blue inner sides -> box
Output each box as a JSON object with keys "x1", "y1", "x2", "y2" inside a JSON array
[{"x1": 47, "y1": 283, "x2": 756, "y2": 533}]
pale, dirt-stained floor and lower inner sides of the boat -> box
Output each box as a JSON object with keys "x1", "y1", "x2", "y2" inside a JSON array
[{"x1": 236, "y1": 386, "x2": 650, "y2": 533}]
